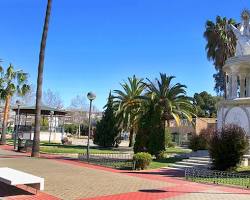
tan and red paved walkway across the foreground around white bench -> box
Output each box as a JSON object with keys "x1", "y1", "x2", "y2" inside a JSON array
[{"x1": 0, "y1": 146, "x2": 250, "y2": 200}]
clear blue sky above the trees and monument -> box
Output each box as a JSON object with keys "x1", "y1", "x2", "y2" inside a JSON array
[{"x1": 0, "y1": 0, "x2": 250, "y2": 109}]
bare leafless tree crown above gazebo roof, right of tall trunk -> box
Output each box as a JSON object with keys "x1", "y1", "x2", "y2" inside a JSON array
[{"x1": 43, "y1": 89, "x2": 63, "y2": 109}]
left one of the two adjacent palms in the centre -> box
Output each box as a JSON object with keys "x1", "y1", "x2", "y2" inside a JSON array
[{"x1": 114, "y1": 75, "x2": 145, "y2": 147}]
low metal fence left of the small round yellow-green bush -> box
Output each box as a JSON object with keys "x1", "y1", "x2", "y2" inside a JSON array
[{"x1": 78, "y1": 153, "x2": 135, "y2": 169}]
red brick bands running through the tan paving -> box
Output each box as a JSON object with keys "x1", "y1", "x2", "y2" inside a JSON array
[{"x1": 0, "y1": 145, "x2": 250, "y2": 200}]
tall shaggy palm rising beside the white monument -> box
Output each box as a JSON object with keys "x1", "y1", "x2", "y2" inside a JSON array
[{"x1": 204, "y1": 16, "x2": 236, "y2": 96}]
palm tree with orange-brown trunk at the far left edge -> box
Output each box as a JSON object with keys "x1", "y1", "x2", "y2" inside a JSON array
[{"x1": 0, "y1": 64, "x2": 30, "y2": 144}]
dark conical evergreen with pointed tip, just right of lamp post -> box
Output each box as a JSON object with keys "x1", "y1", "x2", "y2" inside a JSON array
[{"x1": 94, "y1": 93, "x2": 120, "y2": 147}]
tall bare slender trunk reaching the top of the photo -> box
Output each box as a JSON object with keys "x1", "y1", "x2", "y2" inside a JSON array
[{"x1": 31, "y1": 0, "x2": 52, "y2": 157}]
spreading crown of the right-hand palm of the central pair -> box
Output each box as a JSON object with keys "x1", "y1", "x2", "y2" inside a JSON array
[{"x1": 147, "y1": 73, "x2": 195, "y2": 133}]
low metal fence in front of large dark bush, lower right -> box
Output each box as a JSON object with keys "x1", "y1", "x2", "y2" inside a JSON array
[{"x1": 185, "y1": 168, "x2": 250, "y2": 188}]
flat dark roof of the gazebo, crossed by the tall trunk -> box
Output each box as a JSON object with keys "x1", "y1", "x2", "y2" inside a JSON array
[{"x1": 12, "y1": 105, "x2": 67, "y2": 115}]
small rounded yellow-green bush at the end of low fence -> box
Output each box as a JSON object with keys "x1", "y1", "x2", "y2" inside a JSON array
[{"x1": 133, "y1": 152, "x2": 152, "y2": 170}]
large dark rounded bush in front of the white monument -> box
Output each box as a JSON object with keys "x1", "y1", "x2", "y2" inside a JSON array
[{"x1": 209, "y1": 125, "x2": 249, "y2": 170}]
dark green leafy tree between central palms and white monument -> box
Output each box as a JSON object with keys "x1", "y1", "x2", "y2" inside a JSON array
[{"x1": 194, "y1": 91, "x2": 220, "y2": 117}]
